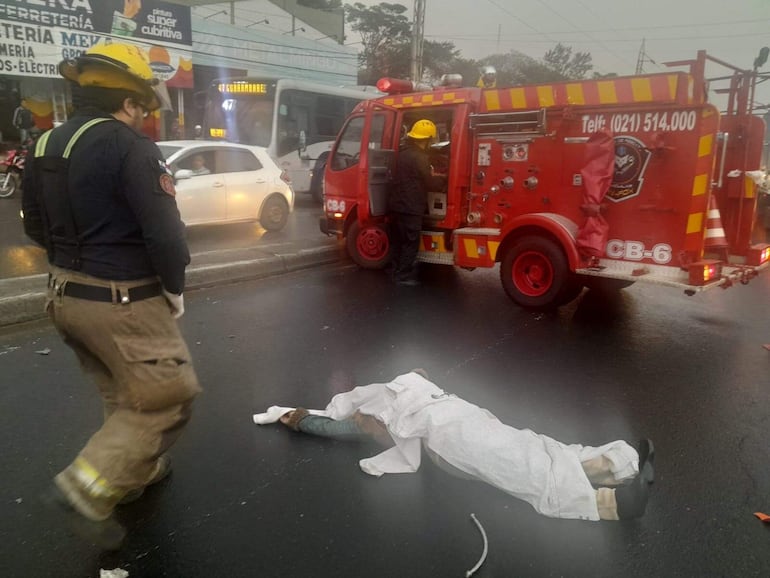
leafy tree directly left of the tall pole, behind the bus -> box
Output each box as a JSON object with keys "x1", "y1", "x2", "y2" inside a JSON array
[{"x1": 345, "y1": 2, "x2": 412, "y2": 84}]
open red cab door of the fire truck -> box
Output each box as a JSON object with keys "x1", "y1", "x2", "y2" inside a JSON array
[{"x1": 359, "y1": 106, "x2": 398, "y2": 217}]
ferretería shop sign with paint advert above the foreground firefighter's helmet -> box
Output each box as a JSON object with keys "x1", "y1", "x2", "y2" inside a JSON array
[{"x1": 0, "y1": 0, "x2": 192, "y2": 87}]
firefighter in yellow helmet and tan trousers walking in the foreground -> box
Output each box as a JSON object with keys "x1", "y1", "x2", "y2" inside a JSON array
[{"x1": 22, "y1": 44, "x2": 200, "y2": 548}]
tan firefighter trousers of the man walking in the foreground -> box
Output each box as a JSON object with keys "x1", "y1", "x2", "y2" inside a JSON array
[{"x1": 46, "y1": 268, "x2": 201, "y2": 500}]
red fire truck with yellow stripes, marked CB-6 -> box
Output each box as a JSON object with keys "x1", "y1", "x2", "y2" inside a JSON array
[{"x1": 320, "y1": 52, "x2": 770, "y2": 309}]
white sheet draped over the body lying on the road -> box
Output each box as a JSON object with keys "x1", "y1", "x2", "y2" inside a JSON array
[{"x1": 326, "y1": 373, "x2": 639, "y2": 520}]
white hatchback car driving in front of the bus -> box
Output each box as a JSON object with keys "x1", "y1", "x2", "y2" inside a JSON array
[{"x1": 156, "y1": 140, "x2": 294, "y2": 231}]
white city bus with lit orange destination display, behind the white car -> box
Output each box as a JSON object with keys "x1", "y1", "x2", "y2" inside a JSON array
[{"x1": 202, "y1": 77, "x2": 382, "y2": 201}]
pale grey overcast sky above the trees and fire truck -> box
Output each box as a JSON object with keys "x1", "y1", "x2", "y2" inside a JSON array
[{"x1": 197, "y1": 0, "x2": 770, "y2": 104}]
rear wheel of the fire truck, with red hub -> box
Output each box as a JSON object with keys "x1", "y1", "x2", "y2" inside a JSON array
[{"x1": 500, "y1": 236, "x2": 577, "y2": 310}]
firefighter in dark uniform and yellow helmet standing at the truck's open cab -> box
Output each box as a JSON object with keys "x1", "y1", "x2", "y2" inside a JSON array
[{"x1": 388, "y1": 119, "x2": 446, "y2": 285}]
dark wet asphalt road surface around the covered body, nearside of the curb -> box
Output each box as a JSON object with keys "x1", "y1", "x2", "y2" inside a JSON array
[{"x1": 0, "y1": 265, "x2": 770, "y2": 578}]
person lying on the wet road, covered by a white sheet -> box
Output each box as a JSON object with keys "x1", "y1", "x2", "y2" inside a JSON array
[{"x1": 254, "y1": 370, "x2": 654, "y2": 520}]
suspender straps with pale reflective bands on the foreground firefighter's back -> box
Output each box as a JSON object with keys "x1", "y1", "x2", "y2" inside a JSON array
[{"x1": 35, "y1": 117, "x2": 115, "y2": 271}]
